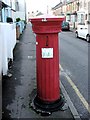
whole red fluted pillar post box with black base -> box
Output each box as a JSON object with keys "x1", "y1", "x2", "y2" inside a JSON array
[{"x1": 30, "y1": 17, "x2": 63, "y2": 112}]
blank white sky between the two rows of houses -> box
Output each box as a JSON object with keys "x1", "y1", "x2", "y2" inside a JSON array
[{"x1": 26, "y1": 0, "x2": 60, "y2": 13}]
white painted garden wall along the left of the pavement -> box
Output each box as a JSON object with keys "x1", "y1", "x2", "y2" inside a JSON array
[{"x1": 0, "y1": 23, "x2": 16, "y2": 75}]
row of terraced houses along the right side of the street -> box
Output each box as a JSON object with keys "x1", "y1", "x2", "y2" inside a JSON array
[{"x1": 52, "y1": 0, "x2": 90, "y2": 28}]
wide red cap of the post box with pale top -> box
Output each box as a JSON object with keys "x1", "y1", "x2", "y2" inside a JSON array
[{"x1": 29, "y1": 15, "x2": 64, "y2": 33}]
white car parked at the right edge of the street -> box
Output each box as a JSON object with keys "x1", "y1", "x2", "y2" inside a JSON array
[{"x1": 75, "y1": 25, "x2": 90, "y2": 42}]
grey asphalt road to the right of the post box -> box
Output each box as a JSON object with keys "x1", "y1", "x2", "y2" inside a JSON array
[{"x1": 59, "y1": 32, "x2": 90, "y2": 118}]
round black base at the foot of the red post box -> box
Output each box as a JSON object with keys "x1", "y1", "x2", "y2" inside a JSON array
[{"x1": 33, "y1": 96, "x2": 65, "y2": 112}]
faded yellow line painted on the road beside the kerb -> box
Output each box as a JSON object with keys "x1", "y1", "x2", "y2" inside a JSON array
[{"x1": 59, "y1": 64, "x2": 90, "y2": 113}]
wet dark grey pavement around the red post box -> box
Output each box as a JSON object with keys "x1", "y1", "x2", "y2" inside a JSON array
[{"x1": 2, "y1": 24, "x2": 79, "y2": 120}]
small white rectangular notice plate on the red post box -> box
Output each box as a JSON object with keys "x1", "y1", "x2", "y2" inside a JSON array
[{"x1": 42, "y1": 48, "x2": 53, "y2": 58}]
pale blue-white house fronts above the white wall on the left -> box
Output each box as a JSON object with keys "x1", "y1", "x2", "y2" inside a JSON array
[{"x1": 0, "y1": 0, "x2": 26, "y2": 22}]
